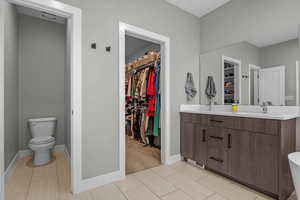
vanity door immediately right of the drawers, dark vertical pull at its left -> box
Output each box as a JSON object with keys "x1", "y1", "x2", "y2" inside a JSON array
[{"x1": 227, "y1": 129, "x2": 253, "y2": 184}]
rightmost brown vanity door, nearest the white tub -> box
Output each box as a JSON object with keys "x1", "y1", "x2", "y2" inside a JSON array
[{"x1": 251, "y1": 133, "x2": 279, "y2": 194}]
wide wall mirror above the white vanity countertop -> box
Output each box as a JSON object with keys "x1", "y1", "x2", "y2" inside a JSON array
[{"x1": 200, "y1": 37, "x2": 300, "y2": 106}]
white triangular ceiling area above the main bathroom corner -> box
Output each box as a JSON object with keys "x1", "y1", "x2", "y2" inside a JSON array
[{"x1": 166, "y1": 0, "x2": 231, "y2": 18}]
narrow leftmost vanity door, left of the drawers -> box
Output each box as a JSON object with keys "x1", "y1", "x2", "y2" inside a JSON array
[{"x1": 195, "y1": 124, "x2": 207, "y2": 165}]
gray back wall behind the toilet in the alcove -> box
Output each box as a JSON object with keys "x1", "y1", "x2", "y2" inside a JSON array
[{"x1": 19, "y1": 15, "x2": 66, "y2": 149}]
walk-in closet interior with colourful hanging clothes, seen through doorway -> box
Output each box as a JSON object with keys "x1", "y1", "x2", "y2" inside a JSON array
[{"x1": 125, "y1": 35, "x2": 161, "y2": 174}]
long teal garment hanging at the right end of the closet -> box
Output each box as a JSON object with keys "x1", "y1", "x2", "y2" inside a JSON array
[{"x1": 153, "y1": 64, "x2": 160, "y2": 136}]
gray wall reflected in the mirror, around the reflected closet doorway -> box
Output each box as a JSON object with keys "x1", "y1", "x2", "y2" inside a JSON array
[{"x1": 199, "y1": 42, "x2": 260, "y2": 104}]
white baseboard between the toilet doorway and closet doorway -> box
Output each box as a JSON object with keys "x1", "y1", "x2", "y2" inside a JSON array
[{"x1": 78, "y1": 171, "x2": 125, "y2": 193}]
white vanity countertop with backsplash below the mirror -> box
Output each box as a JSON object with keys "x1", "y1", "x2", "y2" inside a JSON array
[{"x1": 180, "y1": 105, "x2": 300, "y2": 120}]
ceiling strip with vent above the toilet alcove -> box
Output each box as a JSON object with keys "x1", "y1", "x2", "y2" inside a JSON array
[{"x1": 16, "y1": 5, "x2": 66, "y2": 24}]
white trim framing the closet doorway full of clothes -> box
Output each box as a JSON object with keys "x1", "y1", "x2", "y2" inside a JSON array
[{"x1": 119, "y1": 22, "x2": 171, "y2": 177}]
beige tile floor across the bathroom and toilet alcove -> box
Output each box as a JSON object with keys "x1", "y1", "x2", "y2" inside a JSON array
[{"x1": 5, "y1": 153, "x2": 295, "y2": 200}]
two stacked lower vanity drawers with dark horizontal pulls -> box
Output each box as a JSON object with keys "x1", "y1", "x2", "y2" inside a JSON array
[{"x1": 207, "y1": 127, "x2": 228, "y2": 174}]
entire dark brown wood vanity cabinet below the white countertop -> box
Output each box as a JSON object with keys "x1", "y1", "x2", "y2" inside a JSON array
[{"x1": 181, "y1": 113, "x2": 296, "y2": 200}]
